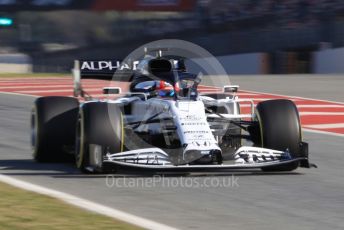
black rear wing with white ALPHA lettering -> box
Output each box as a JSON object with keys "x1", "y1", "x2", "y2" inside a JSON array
[{"x1": 72, "y1": 60, "x2": 136, "y2": 97}]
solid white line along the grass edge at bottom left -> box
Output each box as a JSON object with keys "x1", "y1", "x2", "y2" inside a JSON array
[{"x1": 0, "y1": 174, "x2": 176, "y2": 230}]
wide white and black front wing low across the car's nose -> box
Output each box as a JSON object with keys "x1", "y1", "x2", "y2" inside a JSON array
[{"x1": 103, "y1": 147, "x2": 316, "y2": 171}]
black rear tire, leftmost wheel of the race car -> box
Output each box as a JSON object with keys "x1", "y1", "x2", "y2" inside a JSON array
[{"x1": 31, "y1": 96, "x2": 79, "y2": 162}]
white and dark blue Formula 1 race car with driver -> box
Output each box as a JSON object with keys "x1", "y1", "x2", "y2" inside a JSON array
[{"x1": 31, "y1": 51, "x2": 313, "y2": 173}]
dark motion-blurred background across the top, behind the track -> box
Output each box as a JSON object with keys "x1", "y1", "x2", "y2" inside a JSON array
[{"x1": 0, "y1": 0, "x2": 344, "y2": 74}]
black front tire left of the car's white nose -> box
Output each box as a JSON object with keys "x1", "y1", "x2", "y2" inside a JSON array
[{"x1": 75, "y1": 102, "x2": 124, "y2": 173}]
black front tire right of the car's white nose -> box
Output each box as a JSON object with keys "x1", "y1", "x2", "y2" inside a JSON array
[{"x1": 256, "y1": 99, "x2": 302, "y2": 171}]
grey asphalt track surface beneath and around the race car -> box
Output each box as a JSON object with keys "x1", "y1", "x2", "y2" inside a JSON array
[{"x1": 0, "y1": 74, "x2": 344, "y2": 230}]
